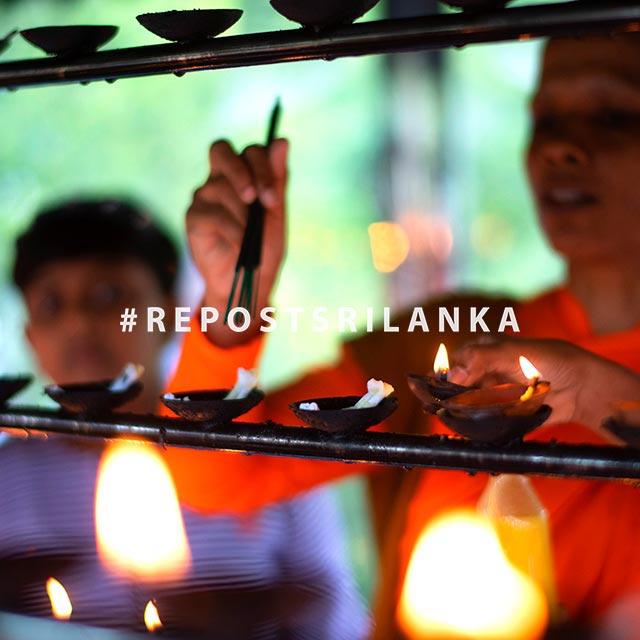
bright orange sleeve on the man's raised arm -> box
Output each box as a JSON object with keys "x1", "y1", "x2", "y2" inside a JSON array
[{"x1": 162, "y1": 321, "x2": 380, "y2": 512}]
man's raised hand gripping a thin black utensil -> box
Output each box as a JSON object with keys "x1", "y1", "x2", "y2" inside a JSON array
[{"x1": 187, "y1": 139, "x2": 289, "y2": 347}]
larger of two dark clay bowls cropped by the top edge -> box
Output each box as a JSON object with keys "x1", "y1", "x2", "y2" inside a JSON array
[{"x1": 271, "y1": 0, "x2": 379, "y2": 29}]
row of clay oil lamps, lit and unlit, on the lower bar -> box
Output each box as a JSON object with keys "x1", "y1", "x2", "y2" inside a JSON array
[{"x1": 0, "y1": 344, "x2": 640, "y2": 447}]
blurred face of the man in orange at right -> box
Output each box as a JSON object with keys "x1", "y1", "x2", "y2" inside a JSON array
[{"x1": 527, "y1": 36, "x2": 640, "y2": 262}]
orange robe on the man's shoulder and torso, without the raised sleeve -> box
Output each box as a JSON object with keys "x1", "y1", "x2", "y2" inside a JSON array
[{"x1": 398, "y1": 289, "x2": 640, "y2": 620}]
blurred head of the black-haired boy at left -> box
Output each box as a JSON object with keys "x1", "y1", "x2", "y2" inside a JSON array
[{"x1": 13, "y1": 200, "x2": 178, "y2": 384}]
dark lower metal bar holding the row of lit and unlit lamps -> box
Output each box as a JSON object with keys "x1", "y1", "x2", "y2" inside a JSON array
[{"x1": 0, "y1": 409, "x2": 640, "y2": 479}]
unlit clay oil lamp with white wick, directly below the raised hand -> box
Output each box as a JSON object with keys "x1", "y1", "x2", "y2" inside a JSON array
[{"x1": 160, "y1": 367, "x2": 264, "y2": 428}]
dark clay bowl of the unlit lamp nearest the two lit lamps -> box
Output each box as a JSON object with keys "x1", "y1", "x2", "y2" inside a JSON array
[{"x1": 289, "y1": 396, "x2": 398, "y2": 433}]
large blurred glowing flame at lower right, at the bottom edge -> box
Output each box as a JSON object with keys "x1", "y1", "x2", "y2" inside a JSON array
[{"x1": 397, "y1": 510, "x2": 548, "y2": 640}]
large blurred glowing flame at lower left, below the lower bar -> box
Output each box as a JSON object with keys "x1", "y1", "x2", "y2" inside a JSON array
[{"x1": 95, "y1": 442, "x2": 191, "y2": 580}]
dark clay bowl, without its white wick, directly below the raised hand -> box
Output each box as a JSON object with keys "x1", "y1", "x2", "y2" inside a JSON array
[{"x1": 160, "y1": 389, "x2": 264, "y2": 423}]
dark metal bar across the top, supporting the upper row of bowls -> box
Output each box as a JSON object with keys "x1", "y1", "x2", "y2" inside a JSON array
[{"x1": 0, "y1": 0, "x2": 640, "y2": 89}]
